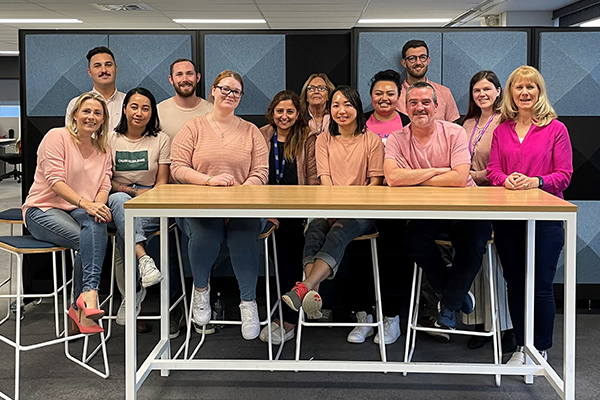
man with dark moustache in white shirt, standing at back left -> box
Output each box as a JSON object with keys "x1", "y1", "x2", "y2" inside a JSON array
[{"x1": 65, "y1": 46, "x2": 125, "y2": 132}]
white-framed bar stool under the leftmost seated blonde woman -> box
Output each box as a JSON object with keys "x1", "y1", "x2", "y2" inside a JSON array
[{"x1": 0, "y1": 235, "x2": 109, "y2": 400}]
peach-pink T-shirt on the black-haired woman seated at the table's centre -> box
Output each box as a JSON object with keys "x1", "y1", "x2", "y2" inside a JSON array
[{"x1": 316, "y1": 130, "x2": 384, "y2": 186}]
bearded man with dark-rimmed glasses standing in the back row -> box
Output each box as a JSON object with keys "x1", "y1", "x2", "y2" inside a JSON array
[{"x1": 396, "y1": 40, "x2": 460, "y2": 122}]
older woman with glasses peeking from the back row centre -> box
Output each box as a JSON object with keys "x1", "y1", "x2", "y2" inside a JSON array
[{"x1": 300, "y1": 73, "x2": 335, "y2": 135}]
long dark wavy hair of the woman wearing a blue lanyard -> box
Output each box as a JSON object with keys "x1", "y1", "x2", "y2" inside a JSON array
[{"x1": 265, "y1": 90, "x2": 309, "y2": 161}]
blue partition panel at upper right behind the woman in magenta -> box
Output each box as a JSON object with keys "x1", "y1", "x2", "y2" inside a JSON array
[{"x1": 539, "y1": 32, "x2": 600, "y2": 116}]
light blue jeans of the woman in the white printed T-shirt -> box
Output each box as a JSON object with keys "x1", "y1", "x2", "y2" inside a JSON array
[{"x1": 108, "y1": 192, "x2": 160, "y2": 279}]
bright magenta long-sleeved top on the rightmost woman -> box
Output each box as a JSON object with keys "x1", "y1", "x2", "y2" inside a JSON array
[{"x1": 487, "y1": 119, "x2": 573, "y2": 198}]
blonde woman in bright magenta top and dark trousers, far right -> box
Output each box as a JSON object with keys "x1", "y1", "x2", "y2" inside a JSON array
[{"x1": 487, "y1": 66, "x2": 573, "y2": 365}]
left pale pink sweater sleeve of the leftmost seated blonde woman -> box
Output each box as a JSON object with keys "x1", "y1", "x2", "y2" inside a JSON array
[{"x1": 38, "y1": 130, "x2": 67, "y2": 187}]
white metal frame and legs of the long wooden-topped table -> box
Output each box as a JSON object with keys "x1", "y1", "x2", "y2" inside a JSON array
[{"x1": 124, "y1": 191, "x2": 577, "y2": 400}]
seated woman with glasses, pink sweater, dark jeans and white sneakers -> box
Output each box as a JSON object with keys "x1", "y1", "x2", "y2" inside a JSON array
[{"x1": 171, "y1": 70, "x2": 269, "y2": 340}]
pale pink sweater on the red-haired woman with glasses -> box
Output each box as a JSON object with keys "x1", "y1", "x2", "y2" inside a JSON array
[{"x1": 171, "y1": 114, "x2": 269, "y2": 185}]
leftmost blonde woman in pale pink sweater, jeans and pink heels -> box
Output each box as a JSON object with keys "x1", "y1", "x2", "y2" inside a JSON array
[{"x1": 23, "y1": 92, "x2": 112, "y2": 333}]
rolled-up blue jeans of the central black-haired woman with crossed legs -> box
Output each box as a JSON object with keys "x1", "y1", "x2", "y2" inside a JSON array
[{"x1": 302, "y1": 218, "x2": 375, "y2": 279}]
